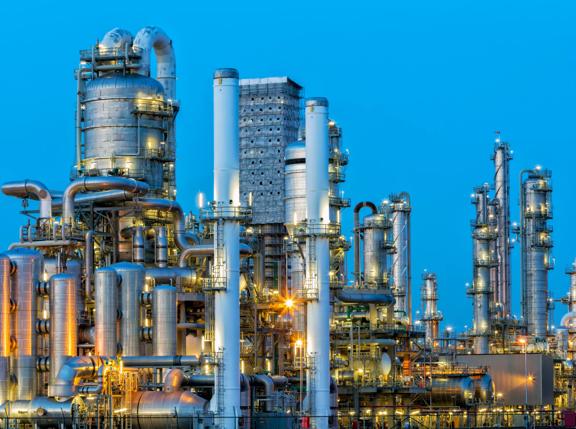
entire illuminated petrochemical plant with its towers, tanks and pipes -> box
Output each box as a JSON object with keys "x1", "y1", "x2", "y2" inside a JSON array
[{"x1": 0, "y1": 27, "x2": 576, "y2": 429}]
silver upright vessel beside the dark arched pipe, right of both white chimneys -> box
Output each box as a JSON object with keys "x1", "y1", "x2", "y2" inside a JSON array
[{"x1": 363, "y1": 213, "x2": 388, "y2": 287}]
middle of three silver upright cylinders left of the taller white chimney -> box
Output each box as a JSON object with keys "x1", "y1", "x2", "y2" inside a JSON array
[{"x1": 111, "y1": 262, "x2": 146, "y2": 356}]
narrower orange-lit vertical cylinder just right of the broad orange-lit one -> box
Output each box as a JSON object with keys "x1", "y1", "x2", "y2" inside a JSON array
[{"x1": 48, "y1": 273, "x2": 78, "y2": 391}]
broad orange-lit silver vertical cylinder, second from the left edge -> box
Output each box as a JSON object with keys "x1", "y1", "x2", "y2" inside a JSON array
[{"x1": 6, "y1": 249, "x2": 43, "y2": 400}]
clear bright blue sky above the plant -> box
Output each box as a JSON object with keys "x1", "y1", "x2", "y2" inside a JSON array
[{"x1": 0, "y1": 0, "x2": 576, "y2": 329}]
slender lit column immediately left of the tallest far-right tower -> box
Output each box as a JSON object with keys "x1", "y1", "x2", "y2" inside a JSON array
[{"x1": 470, "y1": 184, "x2": 496, "y2": 354}]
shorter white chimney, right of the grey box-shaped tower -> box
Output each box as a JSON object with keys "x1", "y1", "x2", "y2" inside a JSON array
[{"x1": 306, "y1": 98, "x2": 330, "y2": 429}]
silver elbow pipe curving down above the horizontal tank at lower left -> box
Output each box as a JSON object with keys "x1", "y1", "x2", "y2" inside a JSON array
[{"x1": 49, "y1": 356, "x2": 103, "y2": 398}]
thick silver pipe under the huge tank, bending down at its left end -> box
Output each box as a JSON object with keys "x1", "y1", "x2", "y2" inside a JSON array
[{"x1": 62, "y1": 176, "x2": 150, "y2": 225}]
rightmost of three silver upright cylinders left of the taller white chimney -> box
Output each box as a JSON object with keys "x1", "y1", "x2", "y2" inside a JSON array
[{"x1": 152, "y1": 285, "x2": 176, "y2": 356}]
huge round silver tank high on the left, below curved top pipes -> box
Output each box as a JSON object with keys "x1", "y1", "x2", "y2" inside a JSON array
[{"x1": 83, "y1": 73, "x2": 167, "y2": 194}]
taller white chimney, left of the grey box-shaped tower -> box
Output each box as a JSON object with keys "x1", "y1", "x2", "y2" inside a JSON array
[{"x1": 211, "y1": 69, "x2": 240, "y2": 422}]
